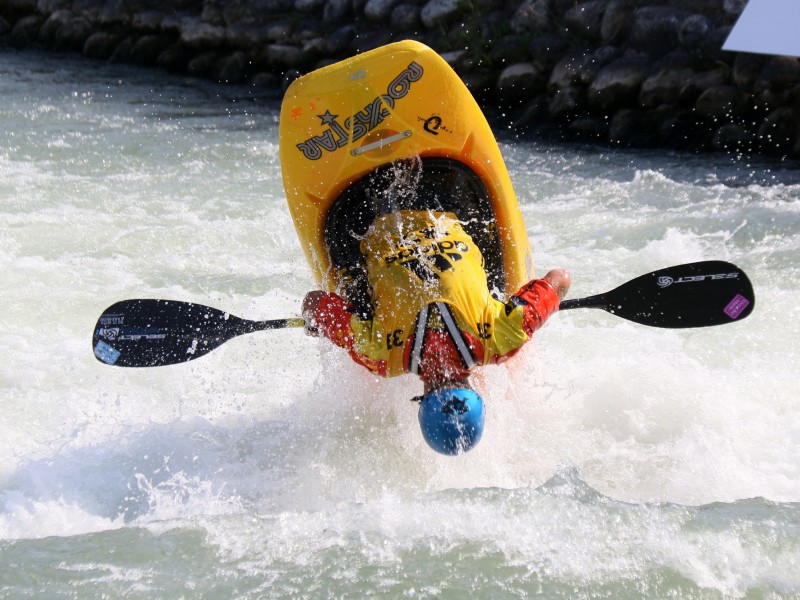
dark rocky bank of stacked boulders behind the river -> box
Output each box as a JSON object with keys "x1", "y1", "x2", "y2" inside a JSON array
[{"x1": 0, "y1": 0, "x2": 800, "y2": 158}]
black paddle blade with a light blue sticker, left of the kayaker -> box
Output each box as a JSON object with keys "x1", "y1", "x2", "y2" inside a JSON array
[{"x1": 92, "y1": 300, "x2": 258, "y2": 367}]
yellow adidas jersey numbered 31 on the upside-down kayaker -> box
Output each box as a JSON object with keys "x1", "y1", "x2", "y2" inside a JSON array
[{"x1": 351, "y1": 210, "x2": 527, "y2": 377}]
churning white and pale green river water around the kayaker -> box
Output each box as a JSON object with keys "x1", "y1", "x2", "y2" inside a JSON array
[{"x1": 0, "y1": 53, "x2": 800, "y2": 598}]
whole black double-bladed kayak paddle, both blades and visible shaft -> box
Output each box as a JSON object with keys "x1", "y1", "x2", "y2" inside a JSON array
[{"x1": 92, "y1": 261, "x2": 755, "y2": 367}]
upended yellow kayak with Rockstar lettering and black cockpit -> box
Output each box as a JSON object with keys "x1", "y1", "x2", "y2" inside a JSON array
[{"x1": 280, "y1": 41, "x2": 533, "y2": 295}]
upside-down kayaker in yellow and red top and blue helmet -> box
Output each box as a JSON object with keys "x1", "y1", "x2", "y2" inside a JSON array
[{"x1": 303, "y1": 210, "x2": 570, "y2": 454}]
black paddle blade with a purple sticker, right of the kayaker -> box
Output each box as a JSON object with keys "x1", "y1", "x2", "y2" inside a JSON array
[{"x1": 559, "y1": 261, "x2": 755, "y2": 329}]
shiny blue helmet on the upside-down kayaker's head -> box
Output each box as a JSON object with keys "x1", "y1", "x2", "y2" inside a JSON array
[{"x1": 418, "y1": 388, "x2": 484, "y2": 455}]
